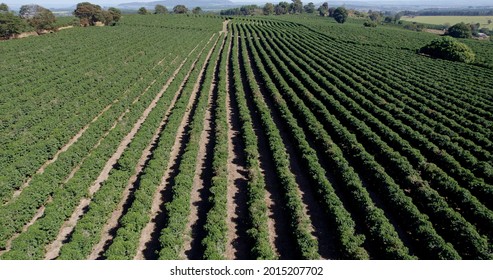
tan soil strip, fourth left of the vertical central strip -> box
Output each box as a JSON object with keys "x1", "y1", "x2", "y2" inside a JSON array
[{"x1": 45, "y1": 53, "x2": 188, "y2": 259}]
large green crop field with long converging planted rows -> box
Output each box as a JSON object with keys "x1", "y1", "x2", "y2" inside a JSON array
[{"x1": 0, "y1": 16, "x2": 493, "y2": 259}]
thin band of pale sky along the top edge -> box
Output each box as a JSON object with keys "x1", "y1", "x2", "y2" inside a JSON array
[{"x1": 0, "y1": 0, "x2": 491, "y2": 8}]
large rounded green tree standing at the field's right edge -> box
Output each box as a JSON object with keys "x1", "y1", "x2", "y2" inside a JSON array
[{"x1": 418, "y1": 36, "x2": 475, "y2": 63}]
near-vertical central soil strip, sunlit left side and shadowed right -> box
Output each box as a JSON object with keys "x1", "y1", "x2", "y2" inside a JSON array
[{"x1": 225, "y1": 37, "x2": 250, "y2": 260}]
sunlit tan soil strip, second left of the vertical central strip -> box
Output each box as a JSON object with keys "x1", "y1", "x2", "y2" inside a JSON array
[{"x1": 134, "y1": 35, "x2": 217, "y2": 260}]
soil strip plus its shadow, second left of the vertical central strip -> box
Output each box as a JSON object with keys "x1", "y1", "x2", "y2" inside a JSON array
[{"x1": 134, "y1": 35, "x2": 217, "y2": 260}]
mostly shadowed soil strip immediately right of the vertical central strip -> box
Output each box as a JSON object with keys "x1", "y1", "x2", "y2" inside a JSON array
[{"x1": 236, "y1": 38, "x2": 297, "y2": 259}]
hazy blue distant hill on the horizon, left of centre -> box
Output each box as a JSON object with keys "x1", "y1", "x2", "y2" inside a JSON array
[{"x1": 118, "y1": 0, "x2": 234, "y2": 9}]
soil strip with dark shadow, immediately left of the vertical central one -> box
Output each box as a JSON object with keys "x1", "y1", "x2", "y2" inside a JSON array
[{"x1": 182, "y1": 37, "x2": 226, "y2": 259}]
